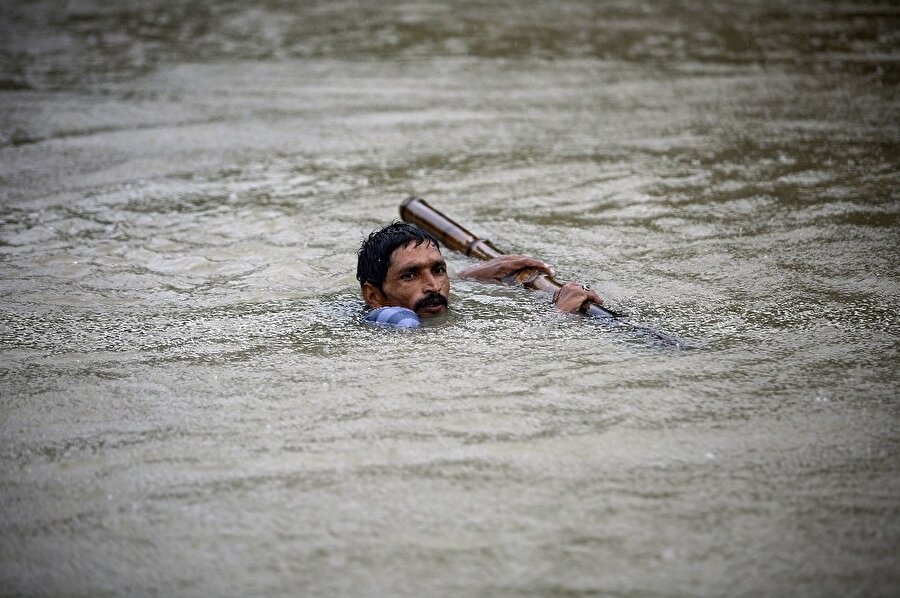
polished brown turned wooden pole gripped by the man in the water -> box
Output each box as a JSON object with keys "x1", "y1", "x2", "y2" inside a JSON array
[{"x1": 400, "y1": 196, "x2": 689, "y2": 349}]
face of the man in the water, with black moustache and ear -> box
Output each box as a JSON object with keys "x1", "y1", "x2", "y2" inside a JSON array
[{"x1": 363, "y1": 242, "x2": 450, "y2": 317}]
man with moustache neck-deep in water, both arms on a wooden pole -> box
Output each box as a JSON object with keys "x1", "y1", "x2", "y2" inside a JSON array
[{"x1": 356, "y1": 222, "x2": 602, "y2": 327}]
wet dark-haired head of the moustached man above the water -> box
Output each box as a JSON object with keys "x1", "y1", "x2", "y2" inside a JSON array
[{"x1": 356, "y1": 222, "x2": 450, "y2": 317}]
